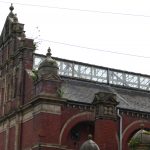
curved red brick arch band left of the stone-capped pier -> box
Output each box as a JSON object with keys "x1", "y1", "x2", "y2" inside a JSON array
[{"x1": 59, "y1": 112, "x2": 95, "y2": 144}]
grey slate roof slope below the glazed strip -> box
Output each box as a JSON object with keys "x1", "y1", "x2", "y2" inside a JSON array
[{"x1": 62, "y1": 78, "x2": 150, "y2": 112}]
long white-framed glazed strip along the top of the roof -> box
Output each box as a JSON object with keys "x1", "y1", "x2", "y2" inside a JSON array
[{"x1": 33, "y1": 54, "x2": 150, "y2": 91}]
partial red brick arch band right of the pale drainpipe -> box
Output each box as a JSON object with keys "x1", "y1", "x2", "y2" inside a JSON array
[{"x1": 122, "y1": 120, "x2": 150, "y2": 150}]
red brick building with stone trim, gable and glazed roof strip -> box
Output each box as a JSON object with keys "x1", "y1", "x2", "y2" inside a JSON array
[{"x1": 0, "y1": 6, "x2": 150, "y2": 150}]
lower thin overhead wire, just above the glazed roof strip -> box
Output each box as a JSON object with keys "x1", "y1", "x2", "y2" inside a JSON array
[{"x1": 33, "y1": 39, "x2": 150, "y2": 59}]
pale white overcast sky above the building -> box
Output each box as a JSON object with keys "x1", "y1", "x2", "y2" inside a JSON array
[{"x1": 0, "y1": 0, "x2": 150, "y2": 75}]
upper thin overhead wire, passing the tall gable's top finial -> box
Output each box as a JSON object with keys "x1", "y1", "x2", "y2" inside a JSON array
[{"x1": 0, "y1": 1, "x2": 150, "y2": 18}]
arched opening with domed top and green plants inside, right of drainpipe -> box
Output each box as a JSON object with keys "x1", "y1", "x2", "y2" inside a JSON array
[{"x1": 128, "y1": 129, "x2": 150, "y2": 150}]
